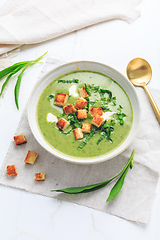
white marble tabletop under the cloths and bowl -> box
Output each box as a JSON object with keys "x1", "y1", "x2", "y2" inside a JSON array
[{"x1": 0, "y1": 0, "x2": 160, "y2": 240}]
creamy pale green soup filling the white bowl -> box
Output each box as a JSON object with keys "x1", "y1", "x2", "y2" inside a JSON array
[{"x1": 36, "y1": 71, "x2": 133, "y2": 158}]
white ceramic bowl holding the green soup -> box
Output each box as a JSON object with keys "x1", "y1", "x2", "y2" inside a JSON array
[{"x1": 28, "y1": 61, "x2": 141, "y2": 164}]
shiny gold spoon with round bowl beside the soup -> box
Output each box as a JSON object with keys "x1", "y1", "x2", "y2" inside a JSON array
[{"x1": 127, "y1": 58, "x2": 160, "y2": 123}]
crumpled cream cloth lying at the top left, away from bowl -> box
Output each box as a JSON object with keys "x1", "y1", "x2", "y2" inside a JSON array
[{"x1": 0, "y1": 0, "x2": 141, "y2": 55}]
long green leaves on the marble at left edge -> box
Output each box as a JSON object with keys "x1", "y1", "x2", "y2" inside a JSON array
[{"x1": 0, "y1": 52, "x2": 47, "y2": 109}]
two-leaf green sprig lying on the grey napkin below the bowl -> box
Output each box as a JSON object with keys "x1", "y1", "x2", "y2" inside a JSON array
[{"x1": 51, "y1": 149, "x2": 135, "y2": 202}]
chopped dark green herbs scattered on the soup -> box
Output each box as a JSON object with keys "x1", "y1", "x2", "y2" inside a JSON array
[{"x1": 53, "y1": 83, "x2": 126, "y2": 150}]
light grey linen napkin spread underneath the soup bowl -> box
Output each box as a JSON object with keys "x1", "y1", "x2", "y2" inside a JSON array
[{"x1": 0, "y1": 58, "x2": 160, "y2": 223}]
